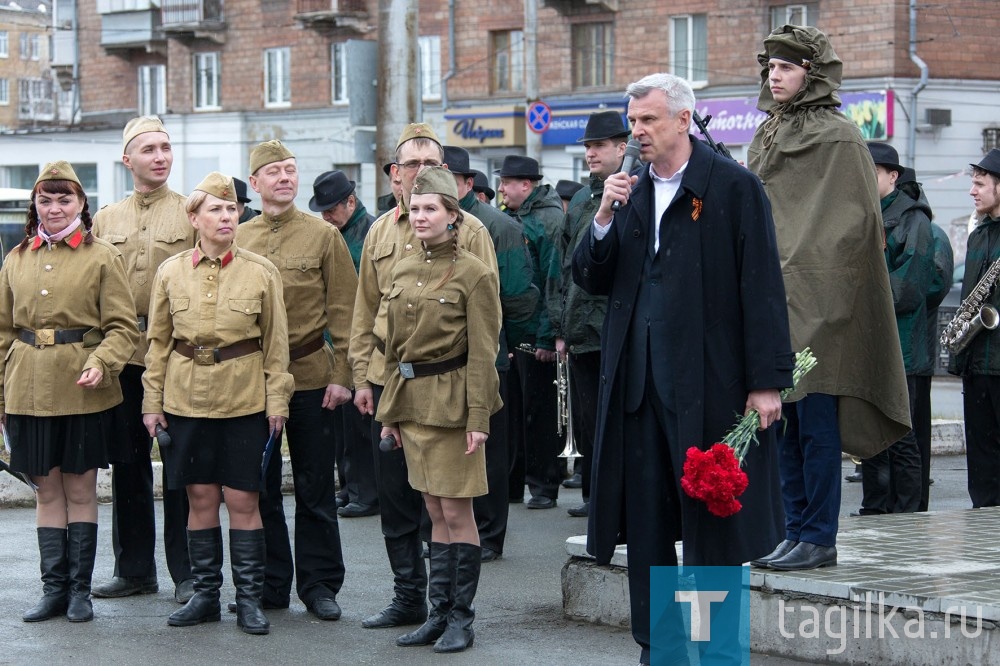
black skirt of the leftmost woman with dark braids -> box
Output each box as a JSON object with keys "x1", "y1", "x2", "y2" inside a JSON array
[{"x1": 7, "y1": 407, "x2": 120, "y2": 476}]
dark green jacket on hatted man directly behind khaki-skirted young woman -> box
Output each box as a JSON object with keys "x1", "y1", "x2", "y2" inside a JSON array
[{"x1": 459, "y1": 192, "x2": 538, "y2": 370}]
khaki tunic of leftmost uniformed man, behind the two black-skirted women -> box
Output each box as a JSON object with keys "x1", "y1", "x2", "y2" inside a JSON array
[{"x1": 94, "y1": 185, "x2": 197, "y2": 365}]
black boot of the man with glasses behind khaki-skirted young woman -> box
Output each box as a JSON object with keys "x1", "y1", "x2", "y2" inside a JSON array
[{"x1": 361, "y1": 533, "x2": 427, "y2": 629}]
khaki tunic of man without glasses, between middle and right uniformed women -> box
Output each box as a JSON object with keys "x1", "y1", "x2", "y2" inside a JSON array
[{"x1": 236, "y1": 206, "x2": 358, "y2": 391}]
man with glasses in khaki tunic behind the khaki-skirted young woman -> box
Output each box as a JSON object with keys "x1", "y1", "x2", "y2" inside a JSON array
[{"x1": 350, "y1": 123, "x2": 497, "y2": 629}]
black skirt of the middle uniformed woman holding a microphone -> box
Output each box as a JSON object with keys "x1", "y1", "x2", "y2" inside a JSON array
[{"x1": 160, "y1": 412, "x2": 281, "y2": 492}]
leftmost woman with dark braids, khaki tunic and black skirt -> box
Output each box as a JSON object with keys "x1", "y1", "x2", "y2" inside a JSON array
[{"x1": 0, "y1": 162, "x2": 139, "y2": 622}]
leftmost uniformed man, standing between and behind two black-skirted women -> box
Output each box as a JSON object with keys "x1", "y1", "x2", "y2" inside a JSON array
[{"x1": 93, "y1": 116, "x2": 195, "y2": 603}]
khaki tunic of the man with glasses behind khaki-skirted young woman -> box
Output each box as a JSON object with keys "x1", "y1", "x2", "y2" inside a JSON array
[{"x1": 350, "y1": 201, "x2": 499, "y2": 390}]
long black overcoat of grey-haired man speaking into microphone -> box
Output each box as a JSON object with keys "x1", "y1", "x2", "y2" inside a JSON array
[{"x1": 573, "y1": 138, "x2": 792, "y2": 565}]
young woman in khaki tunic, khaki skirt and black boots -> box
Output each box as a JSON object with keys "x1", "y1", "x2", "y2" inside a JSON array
[{"x1": 376, "y1": 167, "x2": 502, "y2": 652}]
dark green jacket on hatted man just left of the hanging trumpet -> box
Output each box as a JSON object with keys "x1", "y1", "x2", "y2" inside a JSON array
[{"x1": 508, "y1": 185, "x2": 566, "y2": 351}]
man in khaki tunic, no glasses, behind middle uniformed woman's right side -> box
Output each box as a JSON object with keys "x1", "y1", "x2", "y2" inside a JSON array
[{"x1": 236, "y1": 140, "x2": 358, "y2": 620}]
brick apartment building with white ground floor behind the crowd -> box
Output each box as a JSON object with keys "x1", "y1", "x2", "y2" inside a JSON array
[{"x1": 0, "y1": 0, "x2": 1000, "y2": 232}]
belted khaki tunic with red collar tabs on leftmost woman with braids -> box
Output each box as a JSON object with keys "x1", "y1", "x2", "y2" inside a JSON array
[{"x1": 0, "y1": 227, "x2": 139, "y2": 416}]
